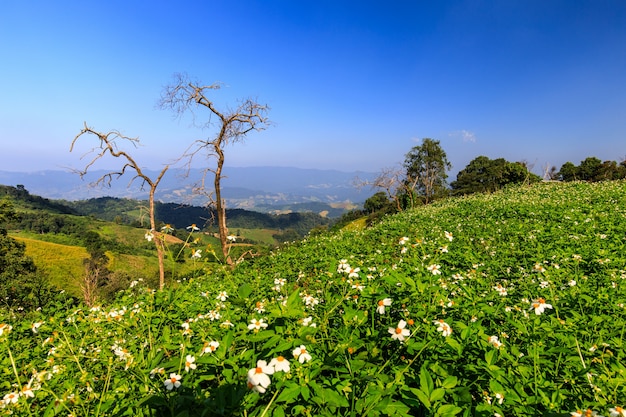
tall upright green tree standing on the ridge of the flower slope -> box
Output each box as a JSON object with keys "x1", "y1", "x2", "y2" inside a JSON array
[{"x1": 404, "y1": 138, "x2": 452, "y2": 206}]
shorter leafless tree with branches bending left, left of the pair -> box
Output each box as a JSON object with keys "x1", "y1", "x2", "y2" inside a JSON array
[{"x1": 70, "y1": 123, "x2": 169, "y2": 289}]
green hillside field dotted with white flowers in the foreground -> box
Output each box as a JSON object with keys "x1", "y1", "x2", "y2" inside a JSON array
[{"x1": 0, "y1": 181, "x2": 626, "y2": 417}]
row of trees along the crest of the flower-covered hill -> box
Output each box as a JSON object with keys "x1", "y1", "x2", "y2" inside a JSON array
[{"x1": 333, "y1": 138, "x2": 626, "y2": 229}]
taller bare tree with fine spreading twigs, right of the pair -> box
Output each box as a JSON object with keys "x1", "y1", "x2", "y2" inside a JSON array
[{"x1": 159, "y1": 74, "x2": 269, "y2": 265}]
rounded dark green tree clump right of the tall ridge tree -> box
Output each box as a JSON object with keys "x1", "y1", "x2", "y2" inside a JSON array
[{"x1": 450, "y1": 156, "x2": 541, "y2": 195}]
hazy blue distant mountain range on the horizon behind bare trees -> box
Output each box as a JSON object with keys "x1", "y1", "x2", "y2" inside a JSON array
[{"x1": 0, "y1": 167, "x2": 376, "y2": 212}]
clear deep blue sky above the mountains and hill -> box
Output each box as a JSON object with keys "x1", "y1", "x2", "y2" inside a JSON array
[{"x1": 0, "y1": 0, "x2": 626, "y2": 179}]
